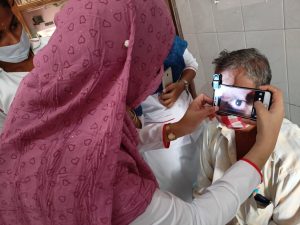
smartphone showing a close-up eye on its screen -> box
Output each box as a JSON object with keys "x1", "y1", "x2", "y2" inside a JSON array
[{"x1": 213, "y1": 84, "x2": 272, "y2": 120}]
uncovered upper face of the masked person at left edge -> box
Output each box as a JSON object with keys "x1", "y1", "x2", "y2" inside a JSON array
[{"x1": 0, "y1": 6, "x2": 22, "y2": 47}]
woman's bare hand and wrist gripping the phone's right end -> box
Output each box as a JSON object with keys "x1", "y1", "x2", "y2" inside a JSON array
[{"x1": 244, "y1": 85, "x2": 284, "y2": 169}]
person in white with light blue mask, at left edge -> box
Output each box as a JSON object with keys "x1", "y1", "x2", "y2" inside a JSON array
[{"x1": 0, "y1": 0, "x2": 48, "y2": 131}]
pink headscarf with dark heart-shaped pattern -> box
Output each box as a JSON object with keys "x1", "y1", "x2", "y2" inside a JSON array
[{"x1": 0, "y1": 0, "x2": 174, "y2": 225}]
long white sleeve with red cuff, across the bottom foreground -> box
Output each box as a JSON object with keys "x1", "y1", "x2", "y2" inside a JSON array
[{"x1": 131, "y1": 161, "x2": 260, "y2": 225}]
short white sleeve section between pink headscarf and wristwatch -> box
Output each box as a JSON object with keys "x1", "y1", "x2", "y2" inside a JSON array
[{"x1": 137, "y1": 123, "x2": 164, "y2": 152}]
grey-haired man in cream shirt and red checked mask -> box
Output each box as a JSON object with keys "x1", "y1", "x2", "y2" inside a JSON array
[{"x1": 194, "y1": 48, "x2": 300, "y2": 225}]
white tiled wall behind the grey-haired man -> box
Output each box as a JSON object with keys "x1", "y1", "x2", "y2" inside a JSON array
[{"x1": 176, "y1": 0, "x2": 300, "y2": 125}]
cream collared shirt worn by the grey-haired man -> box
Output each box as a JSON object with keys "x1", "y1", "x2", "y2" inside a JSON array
[{"x1": 195, "y1": 119, "x2": 300, "y2": 225}]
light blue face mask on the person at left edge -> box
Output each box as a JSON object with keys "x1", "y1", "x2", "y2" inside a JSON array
[{"x1": 0, "y1": 30, "x2": 30, "y2": 63}]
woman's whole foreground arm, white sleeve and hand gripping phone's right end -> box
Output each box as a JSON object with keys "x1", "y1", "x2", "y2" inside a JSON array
[{"x1": 132, "y1": 86, "x2": 284, "y2": 225}]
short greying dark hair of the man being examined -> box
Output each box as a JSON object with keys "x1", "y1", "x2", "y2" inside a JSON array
[{"x1": 213, "y1": 48, "x2": 272, "y2": 87}]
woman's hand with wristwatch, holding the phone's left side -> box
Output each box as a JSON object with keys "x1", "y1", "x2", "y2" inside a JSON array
[{"x1": 170, "y1": 94, "x2": 218, "y2": 138}]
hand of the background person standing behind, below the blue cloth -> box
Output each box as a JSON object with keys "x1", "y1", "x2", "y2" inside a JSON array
[{"x1": 159, "y1": 81, "x2": 184, "y2": 108}]
